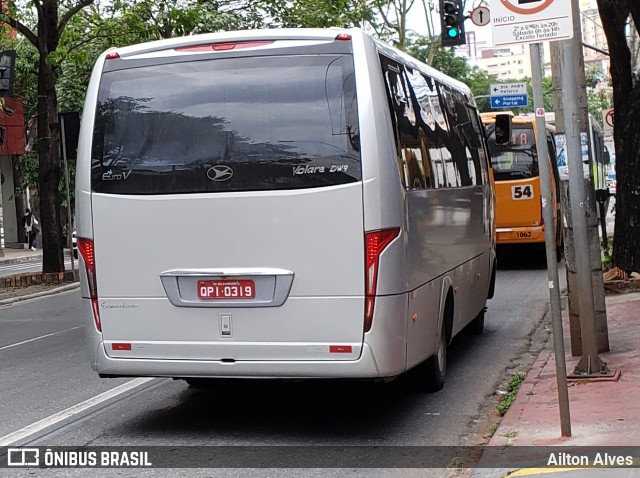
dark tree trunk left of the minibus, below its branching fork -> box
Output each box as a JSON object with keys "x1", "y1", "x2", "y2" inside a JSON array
[{"x1": 37, "y1": 52, "x2": 64, "y2": 272}]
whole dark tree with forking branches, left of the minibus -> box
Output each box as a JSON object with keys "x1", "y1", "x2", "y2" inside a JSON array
[{"x1": 0, "y1": 0, "x2": 93, "y2": 272}]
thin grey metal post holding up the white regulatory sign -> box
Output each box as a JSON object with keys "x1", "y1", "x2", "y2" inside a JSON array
[{"x1": 529, "y1": 43, "x2": 571, "y2": 437}]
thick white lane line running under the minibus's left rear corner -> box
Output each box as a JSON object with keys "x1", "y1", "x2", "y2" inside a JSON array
[{"x1": 0, "y1": 377, "x2": 155, "y2": 447}]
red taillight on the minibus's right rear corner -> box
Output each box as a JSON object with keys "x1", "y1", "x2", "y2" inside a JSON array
[{"x1": 364, "y1": 227, "x2": 400, "y2": 332}]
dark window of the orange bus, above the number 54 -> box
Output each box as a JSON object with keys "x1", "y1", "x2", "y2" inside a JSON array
[{"x1": 487, "y1": 124, "x2": 539, "y2": 181}]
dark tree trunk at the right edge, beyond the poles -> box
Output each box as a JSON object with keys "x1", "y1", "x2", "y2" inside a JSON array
[{"x1": 597, "y1": 0, "x2": 640, "y2": 272}]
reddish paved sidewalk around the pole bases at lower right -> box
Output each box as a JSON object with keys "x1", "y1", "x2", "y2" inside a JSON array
[{"x1": 471, "y1": 293, "x2": 640, "y2": 478}]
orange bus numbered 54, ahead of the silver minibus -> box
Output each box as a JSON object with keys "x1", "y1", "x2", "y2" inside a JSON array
[{"x1": 480, "y1": 112, "x2": 562, "y2": 252}]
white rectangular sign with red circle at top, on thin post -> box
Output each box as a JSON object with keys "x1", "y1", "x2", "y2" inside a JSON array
[{"x1": 491, "y1": 0, "x2": 573, "y2": 46}]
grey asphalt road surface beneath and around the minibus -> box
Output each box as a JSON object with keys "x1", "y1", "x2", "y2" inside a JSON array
[{"x1": 0, "y1": 258, "x2": 564, "y2": 476}]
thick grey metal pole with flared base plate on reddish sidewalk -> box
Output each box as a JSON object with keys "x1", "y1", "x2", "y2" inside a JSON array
[{"x1": 562, "y1": 32, "x2": 613, "y2": 378}]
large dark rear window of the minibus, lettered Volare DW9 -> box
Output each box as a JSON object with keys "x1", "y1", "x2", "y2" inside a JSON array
[{"x1": 92, "y1": 55, "x2": 361, "y2": 194}]
